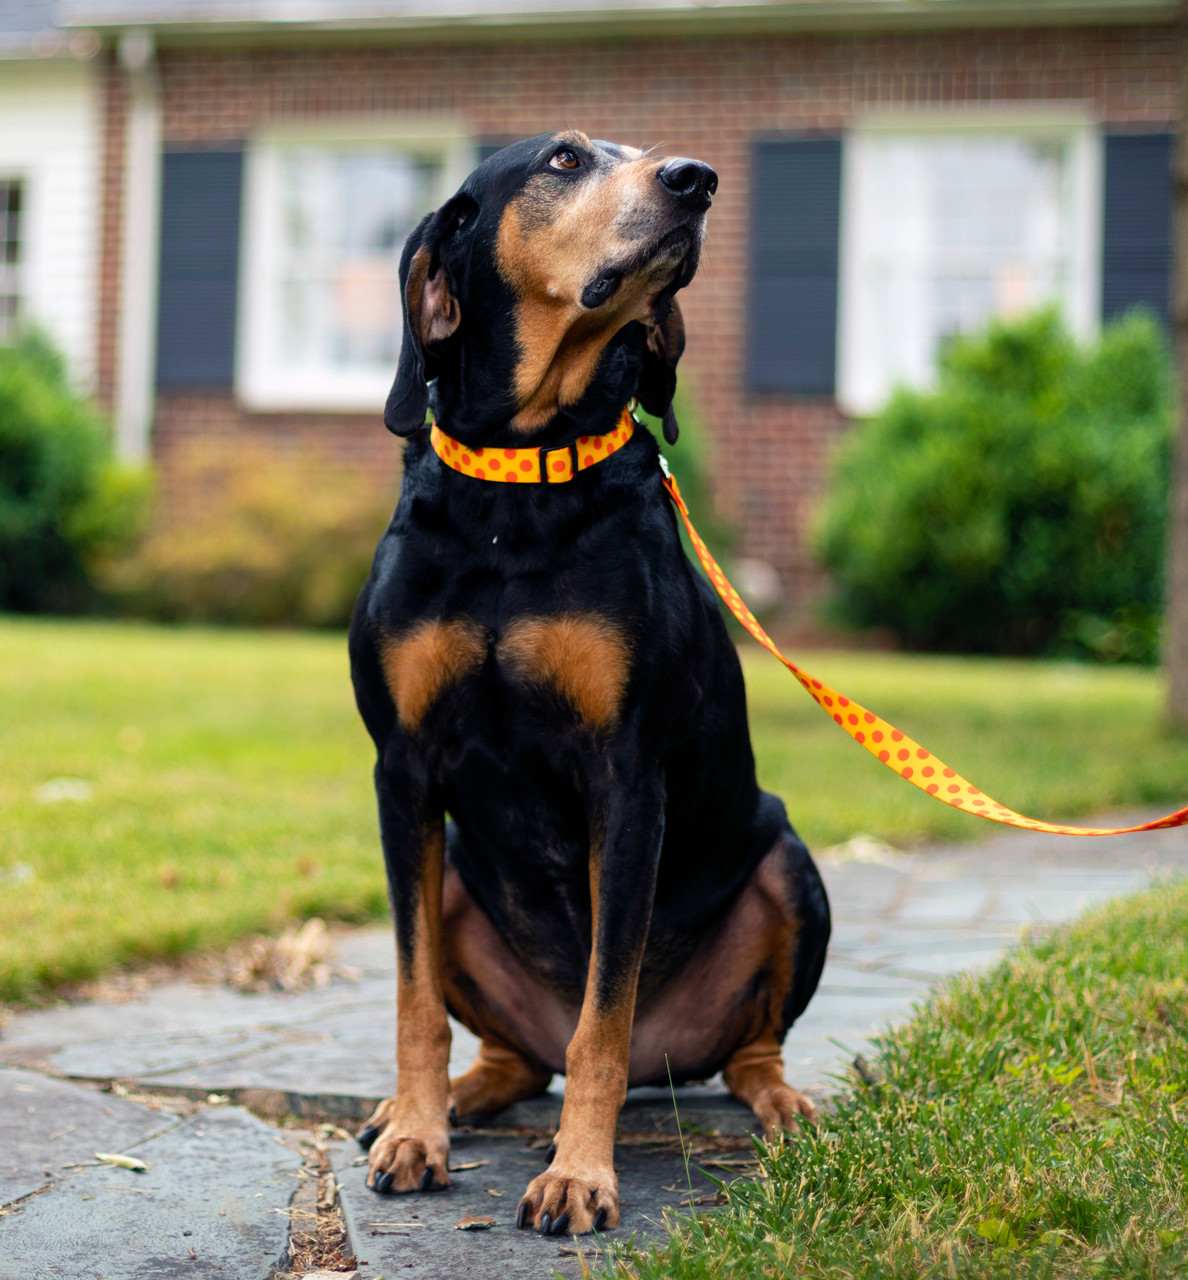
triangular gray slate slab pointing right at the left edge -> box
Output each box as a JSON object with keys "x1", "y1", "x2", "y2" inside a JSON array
[{"x1": 0, "y1": 1068, "x2": 177, "y2": 1208}]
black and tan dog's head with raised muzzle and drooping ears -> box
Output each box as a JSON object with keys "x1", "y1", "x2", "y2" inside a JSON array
[{"x1": 384, "y1": 131, "x2": 717, "y2": 444}]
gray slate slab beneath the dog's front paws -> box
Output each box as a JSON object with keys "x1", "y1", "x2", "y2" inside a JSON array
[{"x1": 332, "y1": 1134, "x2": 722, "y2": 1280}]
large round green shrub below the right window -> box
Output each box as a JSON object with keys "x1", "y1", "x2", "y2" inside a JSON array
[{"x1": 818, "y1": 310, "x2": 1171, "y2": 660}]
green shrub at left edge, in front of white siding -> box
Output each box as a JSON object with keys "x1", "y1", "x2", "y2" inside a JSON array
[{"x1": 0, "y1": 334, "x2": 149, "y2": 613}]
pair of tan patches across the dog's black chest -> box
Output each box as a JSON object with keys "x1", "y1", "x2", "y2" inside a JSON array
[{"x1": 381, "y1": 612, "x2": 631, "y2": 732}]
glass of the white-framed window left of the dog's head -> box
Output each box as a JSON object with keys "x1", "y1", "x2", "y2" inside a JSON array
[{"x1": 275, "y1": 147, "x2": 435, "y2": 370}]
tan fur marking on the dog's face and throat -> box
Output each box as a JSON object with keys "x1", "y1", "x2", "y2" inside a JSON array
[{"x1": 495, "y1": 132, "x2": 677, "y2": 431}]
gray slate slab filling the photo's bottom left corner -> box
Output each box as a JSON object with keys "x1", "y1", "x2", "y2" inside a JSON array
[{"x1": 0, "y1": 1107, "x2": 301, "y2": 1280}]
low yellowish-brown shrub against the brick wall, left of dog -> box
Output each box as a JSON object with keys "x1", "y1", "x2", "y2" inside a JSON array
[{"x1": 104, "y1": 444, "x2": 396, "y2": 627}]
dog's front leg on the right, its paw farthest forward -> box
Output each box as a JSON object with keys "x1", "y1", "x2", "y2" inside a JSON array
[{"x1": 516, "y1": 774, "x2": 664, "y2": 1235}]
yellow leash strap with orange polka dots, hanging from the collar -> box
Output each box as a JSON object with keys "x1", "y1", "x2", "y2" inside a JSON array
[{"x1": 661, "y1": 457, "x2": 1188, "y2": 836}]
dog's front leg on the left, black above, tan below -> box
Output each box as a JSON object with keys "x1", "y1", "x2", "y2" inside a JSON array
[{"x1": 360, "y1": 768, "x2": 449, "y2": 1192}]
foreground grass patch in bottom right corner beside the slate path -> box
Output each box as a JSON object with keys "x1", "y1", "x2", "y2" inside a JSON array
[{"x1": 607, "y1": 881, "x2": 1188, "y2": 1280}]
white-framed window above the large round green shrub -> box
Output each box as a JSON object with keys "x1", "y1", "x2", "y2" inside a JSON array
[{"x1": 839, "y1": 122, "x2": 1101, "y2": 413}]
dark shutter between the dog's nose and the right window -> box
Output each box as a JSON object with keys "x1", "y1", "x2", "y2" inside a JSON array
[{"x1": 746, "y1": 137, "x2": 841, "y2": 396}]
